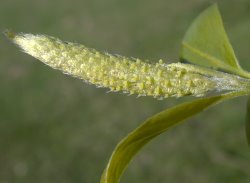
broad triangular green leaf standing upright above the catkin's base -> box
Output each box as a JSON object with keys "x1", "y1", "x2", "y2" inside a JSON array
[{"x1": 181, "y1": 4, "x2": 250, "y2": 77}]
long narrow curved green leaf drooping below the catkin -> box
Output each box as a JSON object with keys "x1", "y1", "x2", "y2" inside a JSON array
[{"x1": 101, "y1": 92, "x2": 245, "y2": 183}]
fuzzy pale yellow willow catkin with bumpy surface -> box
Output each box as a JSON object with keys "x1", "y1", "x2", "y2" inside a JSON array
[{"x1": 7, "y1": 32, "x2": 249, "y2": 98}]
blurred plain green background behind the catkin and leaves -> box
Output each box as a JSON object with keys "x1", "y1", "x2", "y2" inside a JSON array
[{"x1": 0, "y1": 0, "x2": 250, "y2": 183}]
